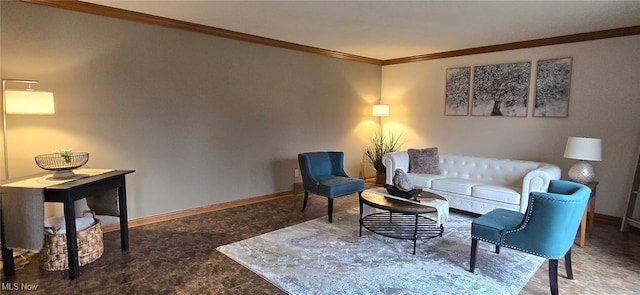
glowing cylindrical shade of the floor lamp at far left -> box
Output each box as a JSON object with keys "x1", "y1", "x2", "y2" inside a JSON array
[{"x1": 4, "y1": 90, "x2": 55, "y2": 115}]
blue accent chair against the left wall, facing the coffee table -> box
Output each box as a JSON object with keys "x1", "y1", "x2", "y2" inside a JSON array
[{"x1": 298, "y1": 152, "x2": 364, "y2": 222}]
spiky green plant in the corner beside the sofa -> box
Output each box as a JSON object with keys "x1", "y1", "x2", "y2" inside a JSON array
[{"x1": 365, "y1": 131, "x2": 402, "y2": 185}]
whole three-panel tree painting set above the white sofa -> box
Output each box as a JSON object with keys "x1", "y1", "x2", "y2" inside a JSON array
[{"x1": 445, "y1": 58, "x2": 572, "y2": 117}]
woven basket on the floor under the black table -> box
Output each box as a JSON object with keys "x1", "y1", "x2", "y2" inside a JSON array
[{"x1": 40, "y1": 211, "x2": 104, "y2": 271}]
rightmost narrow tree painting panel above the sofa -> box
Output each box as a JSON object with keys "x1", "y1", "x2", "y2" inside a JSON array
[{"x1": 533, "y1": 58, "x2": 572, "y2": 117}]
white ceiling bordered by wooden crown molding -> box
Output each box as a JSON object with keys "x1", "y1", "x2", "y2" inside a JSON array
[{"x1": 85, "y1": 0, "x2": 640, "y2": 60}]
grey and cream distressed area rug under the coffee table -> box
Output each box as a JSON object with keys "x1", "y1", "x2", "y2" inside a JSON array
[{"x1": 217, "y1": 209, "x2": 544, "y2": 294}]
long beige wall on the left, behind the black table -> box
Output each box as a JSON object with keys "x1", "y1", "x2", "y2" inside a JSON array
[{"x1": 1, "y1": 1, "x2": 381, "y2": 218}]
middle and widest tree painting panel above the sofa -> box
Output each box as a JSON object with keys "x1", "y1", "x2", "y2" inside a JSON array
[{"x1": 471, "y1": 62, "x2": 531, "y2": 117}]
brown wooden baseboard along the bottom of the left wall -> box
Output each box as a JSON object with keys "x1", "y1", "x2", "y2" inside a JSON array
[{"x1": 101, "y1": 191, "x2": 294, "y2": 232}]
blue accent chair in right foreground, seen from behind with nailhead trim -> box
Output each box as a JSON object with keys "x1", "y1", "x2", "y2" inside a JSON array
[{"x1": 469, "y1": 180, "x2": 591, "y2": 294}]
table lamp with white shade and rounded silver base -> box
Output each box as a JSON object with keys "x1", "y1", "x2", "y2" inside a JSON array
[{"x1": 564, "y1": 137, "x2": 602, "y2": 183}]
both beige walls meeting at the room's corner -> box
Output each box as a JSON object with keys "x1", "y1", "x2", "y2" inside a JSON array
[{"x1": 0, "y1": 1, "x2": 640, "y2": 218}]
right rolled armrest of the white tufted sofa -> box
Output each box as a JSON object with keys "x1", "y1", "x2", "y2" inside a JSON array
[{"x1": 520, "y1": 163, "x2": 562, "y2": 213}]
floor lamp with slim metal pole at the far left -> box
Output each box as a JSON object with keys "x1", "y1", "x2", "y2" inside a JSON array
[{"x1": 2, "y1": 79, "x2": 55, "y2": 179}]
